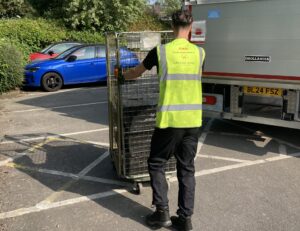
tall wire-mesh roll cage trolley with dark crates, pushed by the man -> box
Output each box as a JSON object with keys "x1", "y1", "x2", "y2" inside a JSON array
[{"x1": 106, "y1": 31, "x2": 176, "y2": 182}]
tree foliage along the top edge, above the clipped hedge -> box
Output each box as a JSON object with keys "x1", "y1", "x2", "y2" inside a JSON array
[{"x1": 0, "y1": 0, "x2": 157, "y2": 32}]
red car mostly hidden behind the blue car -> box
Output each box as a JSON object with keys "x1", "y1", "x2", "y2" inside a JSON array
[{"x1": 29, "y1": 42, "x2": 81, "y2": 61}]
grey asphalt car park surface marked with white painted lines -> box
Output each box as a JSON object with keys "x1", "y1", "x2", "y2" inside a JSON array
[{"x1": 0, "y1": 86, "x2": 300, "y2": 231}]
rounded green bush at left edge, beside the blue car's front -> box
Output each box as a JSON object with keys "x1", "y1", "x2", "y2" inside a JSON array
[{"x1": 0, "y1": 42, "x2": 23, "y2": 94}]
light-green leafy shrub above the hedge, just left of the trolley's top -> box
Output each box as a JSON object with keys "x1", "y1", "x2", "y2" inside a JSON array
[{"x1": 64, "y1": 0, "x2": 146, "y2": 32}]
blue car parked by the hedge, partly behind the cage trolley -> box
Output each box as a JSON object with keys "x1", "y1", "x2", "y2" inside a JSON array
[{"x1": 24, "y1": 45, "x2": 139, "y2": 91}]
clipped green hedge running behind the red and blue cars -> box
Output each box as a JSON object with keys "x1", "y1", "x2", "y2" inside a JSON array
[{"x1": 0, "y1": 19, "x2": 104, "y2": 63}]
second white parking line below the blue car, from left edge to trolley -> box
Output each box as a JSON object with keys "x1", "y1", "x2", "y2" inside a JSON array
[{"x1": 0, "y1": 127, "x2": 109, "y2": 145}]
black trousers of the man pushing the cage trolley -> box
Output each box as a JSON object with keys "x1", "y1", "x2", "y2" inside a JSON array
[{"x1": 148, "y1": 128, "x2": 199, "y2": 216}]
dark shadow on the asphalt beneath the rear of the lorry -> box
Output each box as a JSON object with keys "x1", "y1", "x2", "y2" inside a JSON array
[{"x1": 204, "y1": 119, "x2": 300, "y2": 156}]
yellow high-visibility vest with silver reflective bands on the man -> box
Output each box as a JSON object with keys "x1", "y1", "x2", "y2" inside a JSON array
[{"x1": 156, "y1": 39, "x2": 205, "y2": 128}]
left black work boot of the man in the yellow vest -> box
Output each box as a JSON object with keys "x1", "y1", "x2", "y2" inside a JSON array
[{"x1": 146, "y1": 208, "x2": 172, "y2": 228}]
